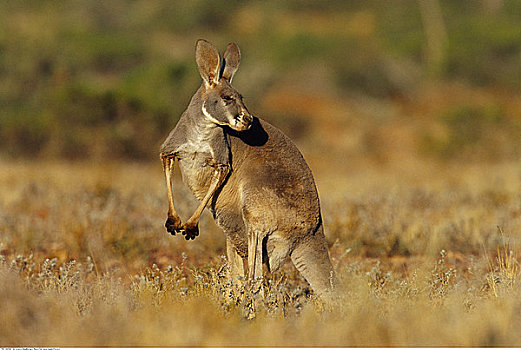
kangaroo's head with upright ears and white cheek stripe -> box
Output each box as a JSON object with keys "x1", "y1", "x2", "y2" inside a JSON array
[{"x1": 195, "y1": 39, "x2": 253, "y2": 131}]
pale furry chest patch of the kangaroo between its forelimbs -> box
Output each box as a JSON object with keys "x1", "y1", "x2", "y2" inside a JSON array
[{"x1": 179, "y1": 152, "x2": 214, "y2": 200}]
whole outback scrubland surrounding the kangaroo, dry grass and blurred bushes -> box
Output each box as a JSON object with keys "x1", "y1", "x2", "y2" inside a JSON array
[{"x1": 0, "y1": 0, "x2": 521, "y2": 347}]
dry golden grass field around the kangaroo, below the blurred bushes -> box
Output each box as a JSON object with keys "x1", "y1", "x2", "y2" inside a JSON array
[{"x1": 0, "y1": 160, "x2": 521, "y2": 346}]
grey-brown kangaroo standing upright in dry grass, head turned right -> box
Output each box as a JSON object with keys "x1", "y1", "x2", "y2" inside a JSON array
[{"x1": 160, "y1": 39, "x2": 334, "y2": 295}]
